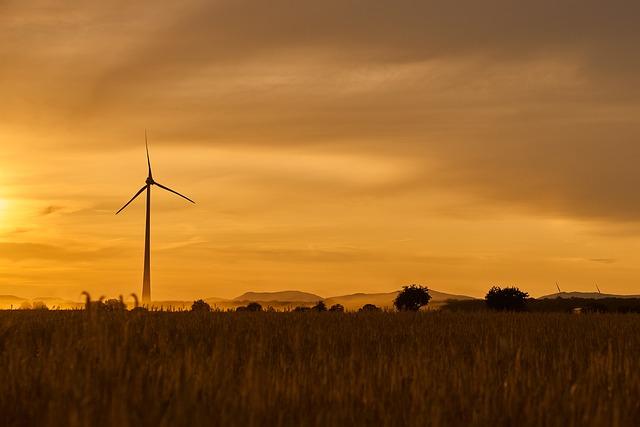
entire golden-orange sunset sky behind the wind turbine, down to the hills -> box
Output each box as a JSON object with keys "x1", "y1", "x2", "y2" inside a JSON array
[{"x1": 0, "y1": 0, "x2": 640, "y2": 300}]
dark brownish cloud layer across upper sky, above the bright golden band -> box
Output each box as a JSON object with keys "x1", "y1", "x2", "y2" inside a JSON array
[{"x1": 0, "y1": 0, "x2": 640, "y2": 222}]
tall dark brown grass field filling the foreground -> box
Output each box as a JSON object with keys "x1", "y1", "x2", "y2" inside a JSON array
[{"x1": 0, "y1": 311, "x2": 640, "y2": 427}]
